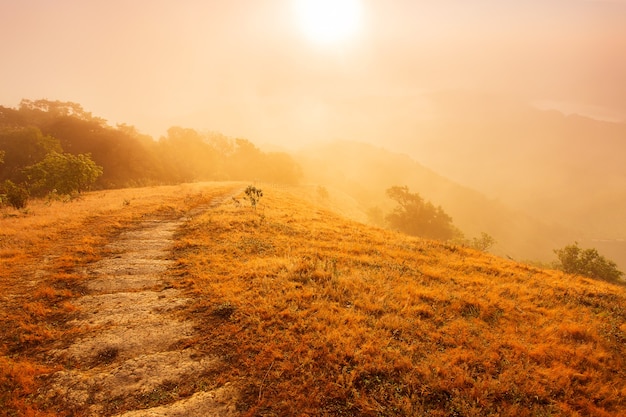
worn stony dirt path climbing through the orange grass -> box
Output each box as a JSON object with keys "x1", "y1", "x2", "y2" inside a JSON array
[{"x1": 44, "y1": 195, "x2": 237, "y2": 417}]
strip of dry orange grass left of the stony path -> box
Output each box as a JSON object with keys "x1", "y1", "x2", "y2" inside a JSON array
[{"x1": 0, "y1": 184, "x2": 240, "y2": 416}]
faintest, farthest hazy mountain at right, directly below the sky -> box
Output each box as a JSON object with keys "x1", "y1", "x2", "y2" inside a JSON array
[{"x1": 392, "y1": 92, "x2": 626, "y2": 239}]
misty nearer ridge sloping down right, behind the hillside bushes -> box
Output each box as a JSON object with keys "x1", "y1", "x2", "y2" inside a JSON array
[{"x1": 298, "y1": 141, "x2": 578, "y2": 261}]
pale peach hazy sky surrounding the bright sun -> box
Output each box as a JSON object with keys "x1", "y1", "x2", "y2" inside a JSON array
[{"x1": 0, "y1": 0, "x2": 626, "y2": 144}]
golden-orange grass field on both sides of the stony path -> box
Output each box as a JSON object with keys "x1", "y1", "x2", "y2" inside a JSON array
[{"x1": 0, "y1": 184, "x2": 626, "y2": 416}]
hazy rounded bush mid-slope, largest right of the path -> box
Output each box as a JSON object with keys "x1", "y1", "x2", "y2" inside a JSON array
[{"x1": 386, "y1": 186, "x2": 461, "y2": 240}]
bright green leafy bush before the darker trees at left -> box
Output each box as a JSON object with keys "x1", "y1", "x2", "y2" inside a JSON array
[{"x1": 24, "y1": 152, "x2": 102, "y2": 195}]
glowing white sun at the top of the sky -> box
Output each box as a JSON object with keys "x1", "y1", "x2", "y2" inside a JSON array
[{"x1": 295, "y1": 0, "x2": 361, "y2": 44}]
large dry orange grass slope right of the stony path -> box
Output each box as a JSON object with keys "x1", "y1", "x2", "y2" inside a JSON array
[{"x1": 172, "y1": 189, "x2": 626, "y2": 416}]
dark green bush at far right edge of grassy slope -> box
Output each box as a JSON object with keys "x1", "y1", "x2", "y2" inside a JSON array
[{"x1": 554, "y1": 242, "x2": 624, "y2": 282}]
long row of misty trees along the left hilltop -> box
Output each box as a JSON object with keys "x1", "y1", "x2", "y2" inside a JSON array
[{"x1": 0, "y1": 100, "x2": 302, "y2": 205}]
